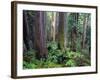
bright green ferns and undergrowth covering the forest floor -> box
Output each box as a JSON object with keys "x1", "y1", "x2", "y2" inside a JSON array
[{"x1": 23, "y1": 42, "x2": 90, "y2": 69}]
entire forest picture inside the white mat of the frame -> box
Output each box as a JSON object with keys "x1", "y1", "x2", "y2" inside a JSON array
[{"x1": 23, "y1": 10, "x2": 91, "y2": 69}]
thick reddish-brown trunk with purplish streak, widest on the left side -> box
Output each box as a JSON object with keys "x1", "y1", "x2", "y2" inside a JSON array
[{"x1": 35, "y1": 11, "x2": 47, "y2": 59}]
